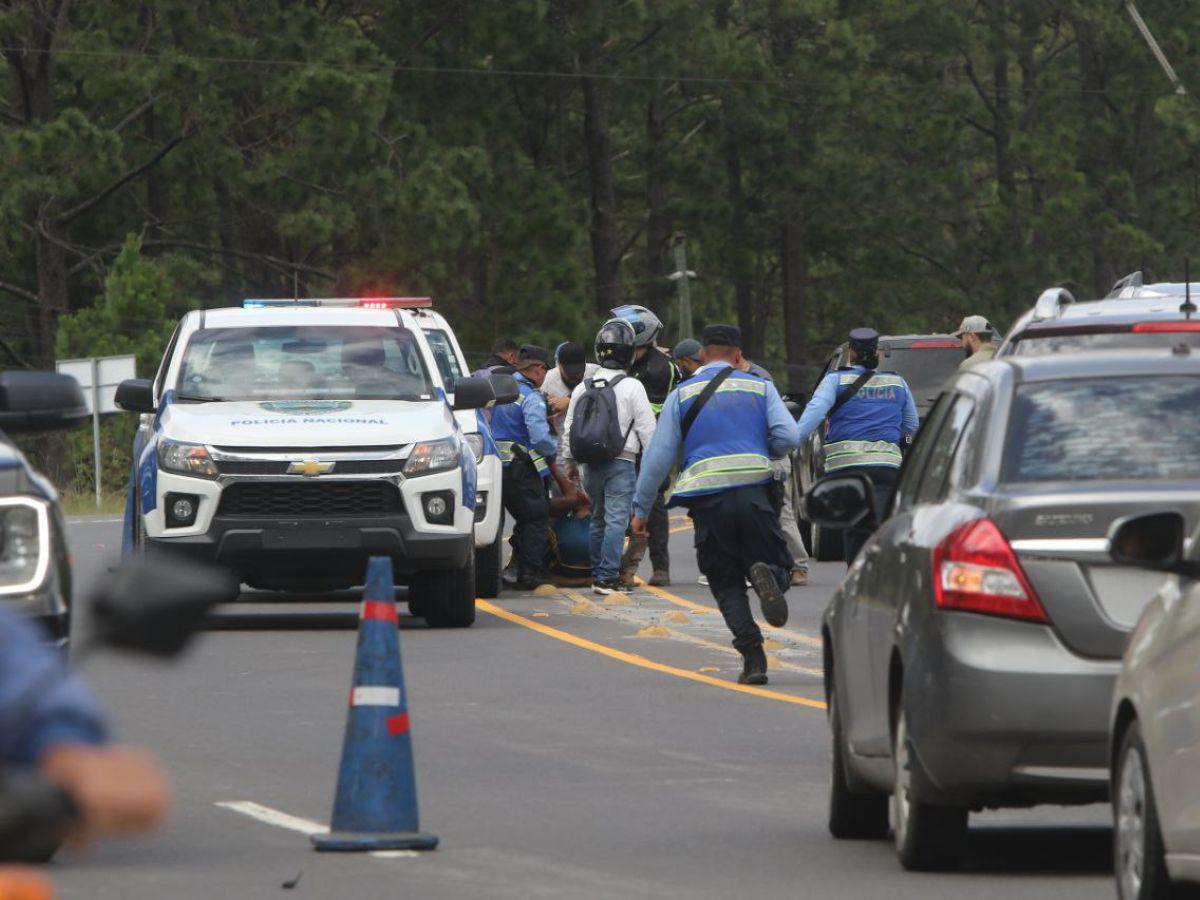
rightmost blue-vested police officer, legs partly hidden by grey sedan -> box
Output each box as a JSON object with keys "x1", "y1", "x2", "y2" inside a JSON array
[{"x1": 799, "y1": 328, "x2": 920, "y2": 565}]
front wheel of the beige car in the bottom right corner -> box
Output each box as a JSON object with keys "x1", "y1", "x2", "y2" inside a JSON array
[{"x1": 1112, "y1": 721, "x2": 1177, "y2": 900}]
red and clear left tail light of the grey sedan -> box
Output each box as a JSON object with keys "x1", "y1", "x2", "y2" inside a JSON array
[{"x1": 934, "y1": 518, "x2": 1050, "y2": 622}]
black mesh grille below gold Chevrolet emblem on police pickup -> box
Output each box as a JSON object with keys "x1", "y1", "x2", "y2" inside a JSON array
[{"x1": 217, "y1": 481, "x2": 402, "y2": 518}]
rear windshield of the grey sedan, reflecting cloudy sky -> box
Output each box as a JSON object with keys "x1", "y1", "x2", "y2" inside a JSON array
[{"x1": 1004, "y1": 376, "x2": 1200, "y2": 482}]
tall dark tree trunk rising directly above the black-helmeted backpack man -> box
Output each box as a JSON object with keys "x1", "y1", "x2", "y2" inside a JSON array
[{"x1": 583, "y1": 78, "x2": 623, "y2": 316}]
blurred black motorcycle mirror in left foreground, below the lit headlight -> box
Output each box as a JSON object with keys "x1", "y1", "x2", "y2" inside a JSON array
[{"x1": 88, "y1": 553, "x2": 240, "y2": 658}]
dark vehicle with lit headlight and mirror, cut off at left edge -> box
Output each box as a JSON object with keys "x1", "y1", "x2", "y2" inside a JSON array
[{"x1": 0, "y1": 372, "x2": 88, "y2": 646}]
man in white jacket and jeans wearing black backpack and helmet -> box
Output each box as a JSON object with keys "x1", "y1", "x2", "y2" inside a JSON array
[{"x1": 563, "y1": 319, "x2": 654, "y2": 595}]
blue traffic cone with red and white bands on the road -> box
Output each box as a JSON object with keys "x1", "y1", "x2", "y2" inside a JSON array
[{"x1": 312, "y1": 557, "x2": 438, "y2": 851}]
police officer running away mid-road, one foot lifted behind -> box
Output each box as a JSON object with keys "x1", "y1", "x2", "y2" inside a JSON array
[{"x1": 634, "y1": 325, "x2": 800, "y2": 684}]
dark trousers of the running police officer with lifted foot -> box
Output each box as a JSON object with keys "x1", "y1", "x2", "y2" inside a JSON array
[{"x1": 690, "y1": 485, "x2": 792, "y2": 650}]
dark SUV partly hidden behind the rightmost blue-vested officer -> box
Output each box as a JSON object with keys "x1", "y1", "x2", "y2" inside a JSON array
[{"x1": 792, "y1": 335, "x2": 964, "y2": 562}]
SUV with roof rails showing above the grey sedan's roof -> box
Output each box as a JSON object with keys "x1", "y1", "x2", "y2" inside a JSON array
[{"x1": 996, "y1": 272, "x2": 1200, "y2": 356}]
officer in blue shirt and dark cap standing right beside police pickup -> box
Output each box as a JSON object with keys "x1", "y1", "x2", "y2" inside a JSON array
[{"x1": 492, "y1": 344, "x2": 558, "y2": 590}]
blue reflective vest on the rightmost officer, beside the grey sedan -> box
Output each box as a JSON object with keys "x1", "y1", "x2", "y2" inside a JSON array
[{"x1": 824, "y1": 366, "x2": 908, "y2": 472}]
